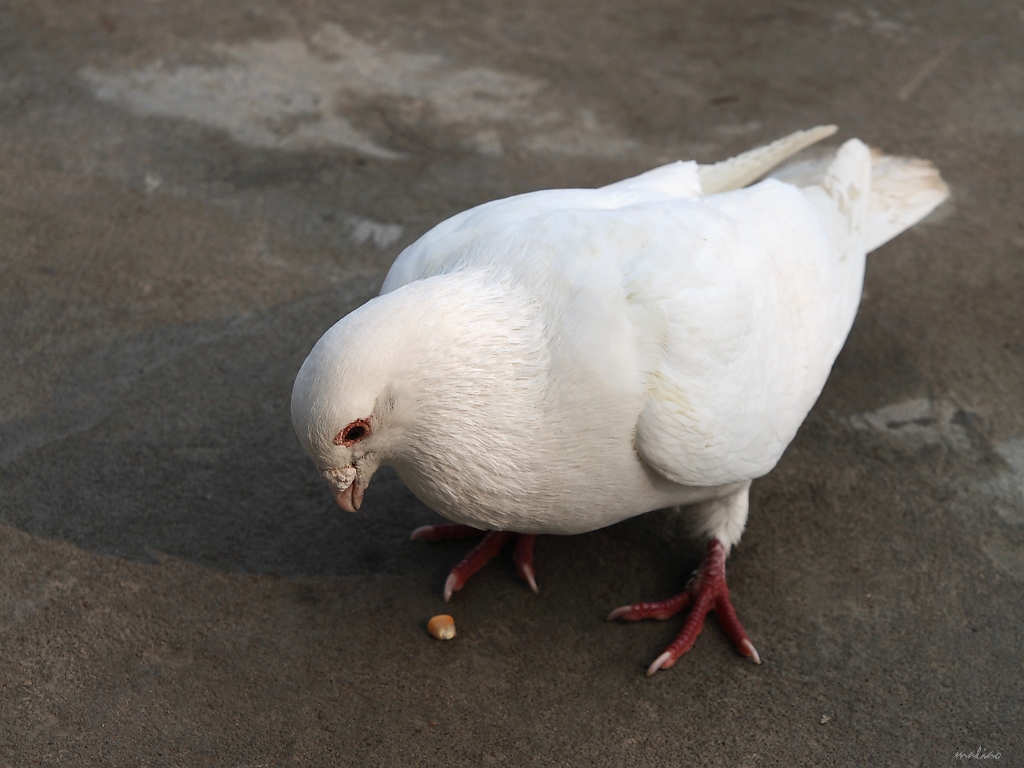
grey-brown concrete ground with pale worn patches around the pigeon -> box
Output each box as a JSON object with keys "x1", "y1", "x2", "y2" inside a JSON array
[{"x1": 0, "y1": 0, "x2": 1024, "y2": 767}]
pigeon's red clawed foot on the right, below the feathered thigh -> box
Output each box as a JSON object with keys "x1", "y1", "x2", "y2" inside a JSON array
[{"x1": 608, "y1": 539, "x2": 761, "y2": 676}]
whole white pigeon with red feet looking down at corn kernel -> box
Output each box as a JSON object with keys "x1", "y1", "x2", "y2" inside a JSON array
[{"x1": 292, "y1": 126, "x2": 948, "y2": 674}]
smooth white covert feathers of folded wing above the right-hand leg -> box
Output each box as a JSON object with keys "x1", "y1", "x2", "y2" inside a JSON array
[{"x1": 631, "y1": 181, "x2": 859, "y2": 485}]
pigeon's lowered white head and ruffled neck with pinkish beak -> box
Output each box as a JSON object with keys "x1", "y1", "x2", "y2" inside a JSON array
[{"x1": 292, "y1": 273, "x2": 548, "y2": 514}]
